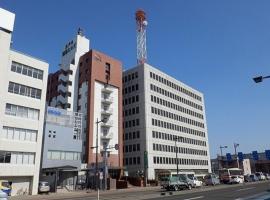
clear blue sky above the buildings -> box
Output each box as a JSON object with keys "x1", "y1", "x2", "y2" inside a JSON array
[{"x1": 0, "y1": 0, "x2": 270, "y2": 157}]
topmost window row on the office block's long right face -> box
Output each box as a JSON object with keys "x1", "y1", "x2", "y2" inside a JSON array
[{"x1": 150, "y1": 72, "x2": 202, "y2": 101}]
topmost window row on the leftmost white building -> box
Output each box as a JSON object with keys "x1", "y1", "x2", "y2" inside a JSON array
[{"x1": 11, "y1": 61, "x2": 43, "y2": 80}]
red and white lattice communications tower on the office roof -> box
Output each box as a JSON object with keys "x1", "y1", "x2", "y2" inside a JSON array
[{"x1": 135, "y1": 10, "x2": 147, "y2": 64}]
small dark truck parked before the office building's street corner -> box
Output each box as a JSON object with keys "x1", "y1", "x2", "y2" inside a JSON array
[{"x1": 160, "y1": 176, "x2": 192, "y2": 191}]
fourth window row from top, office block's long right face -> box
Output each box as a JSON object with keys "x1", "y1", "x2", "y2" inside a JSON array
[{"x1": 151, "y1": 107, "x2": 204, "y2": 128}]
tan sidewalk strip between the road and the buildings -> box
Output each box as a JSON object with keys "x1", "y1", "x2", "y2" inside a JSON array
[{"x1": 10, "y1": 186, "x2": 160, "y2": 200}]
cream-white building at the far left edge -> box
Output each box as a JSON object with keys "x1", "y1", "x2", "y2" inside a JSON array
[{"x1": 0, "y1": 8, "x2": 48, "y2": 195}]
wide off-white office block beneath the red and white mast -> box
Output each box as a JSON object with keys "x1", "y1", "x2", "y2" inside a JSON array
[{"x1": 123, "y1": 64, "x2": 211, "y2": 179}]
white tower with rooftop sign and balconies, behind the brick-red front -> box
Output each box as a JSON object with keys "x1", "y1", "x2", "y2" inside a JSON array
[{"x1": 47, "y1": 29, "x2": 90, "y2": 112}]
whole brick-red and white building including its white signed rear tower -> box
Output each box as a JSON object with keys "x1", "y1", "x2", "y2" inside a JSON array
[{"x1": 47, "y1": 32, "x2": 123, "y2": 176}]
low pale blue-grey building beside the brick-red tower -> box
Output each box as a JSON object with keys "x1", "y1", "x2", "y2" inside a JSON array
[{"x1": 40, "y1": 107, "x2": 82, "y2": 190}]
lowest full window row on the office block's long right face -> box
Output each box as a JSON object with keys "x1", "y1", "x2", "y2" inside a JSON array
[{"x1": 153, "y1": 156, "x2": 208, "y2": 165}]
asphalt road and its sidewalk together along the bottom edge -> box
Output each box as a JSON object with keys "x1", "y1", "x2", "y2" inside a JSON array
[{"x1": 11, "y1": 181, "x2": 270, "y2": 200}]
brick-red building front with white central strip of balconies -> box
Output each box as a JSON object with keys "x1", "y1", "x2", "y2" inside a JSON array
[{"x1": 78, "y1": 50, "x2": 123, "y2": 175}]
